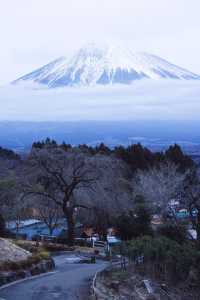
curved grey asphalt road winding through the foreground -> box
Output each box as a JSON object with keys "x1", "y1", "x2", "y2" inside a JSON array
[{"x1": 0, "y1": 254, "x2": 106, "y2": 300}]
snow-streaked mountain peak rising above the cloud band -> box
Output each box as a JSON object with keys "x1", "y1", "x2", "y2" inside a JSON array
[{"x1": 14, "y1": 44, "x2": 200, "y2": 87}]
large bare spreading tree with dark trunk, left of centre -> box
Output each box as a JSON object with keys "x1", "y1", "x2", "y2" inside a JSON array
[{"x1": 24, "y1": 147, "x2": 95, "y2": 244}]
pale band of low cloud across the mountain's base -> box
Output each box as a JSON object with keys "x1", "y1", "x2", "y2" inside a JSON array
[{"x1": 0, "y1": 80, "x2": 200, "y2": 121}]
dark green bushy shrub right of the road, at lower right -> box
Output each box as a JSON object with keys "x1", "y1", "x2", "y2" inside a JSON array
[{"x1": 128, "y1": 236, "x2": 200, "y2": 281}]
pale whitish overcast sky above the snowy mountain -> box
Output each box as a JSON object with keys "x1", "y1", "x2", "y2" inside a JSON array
[{"x1": 0, "y1": 0, "x2": 200, "y2": 84}]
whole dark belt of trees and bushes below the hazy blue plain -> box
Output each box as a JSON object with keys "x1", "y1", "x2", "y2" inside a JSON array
[{"x1": 0, "y1": 139, "x2": 200, "y2": 299}]
